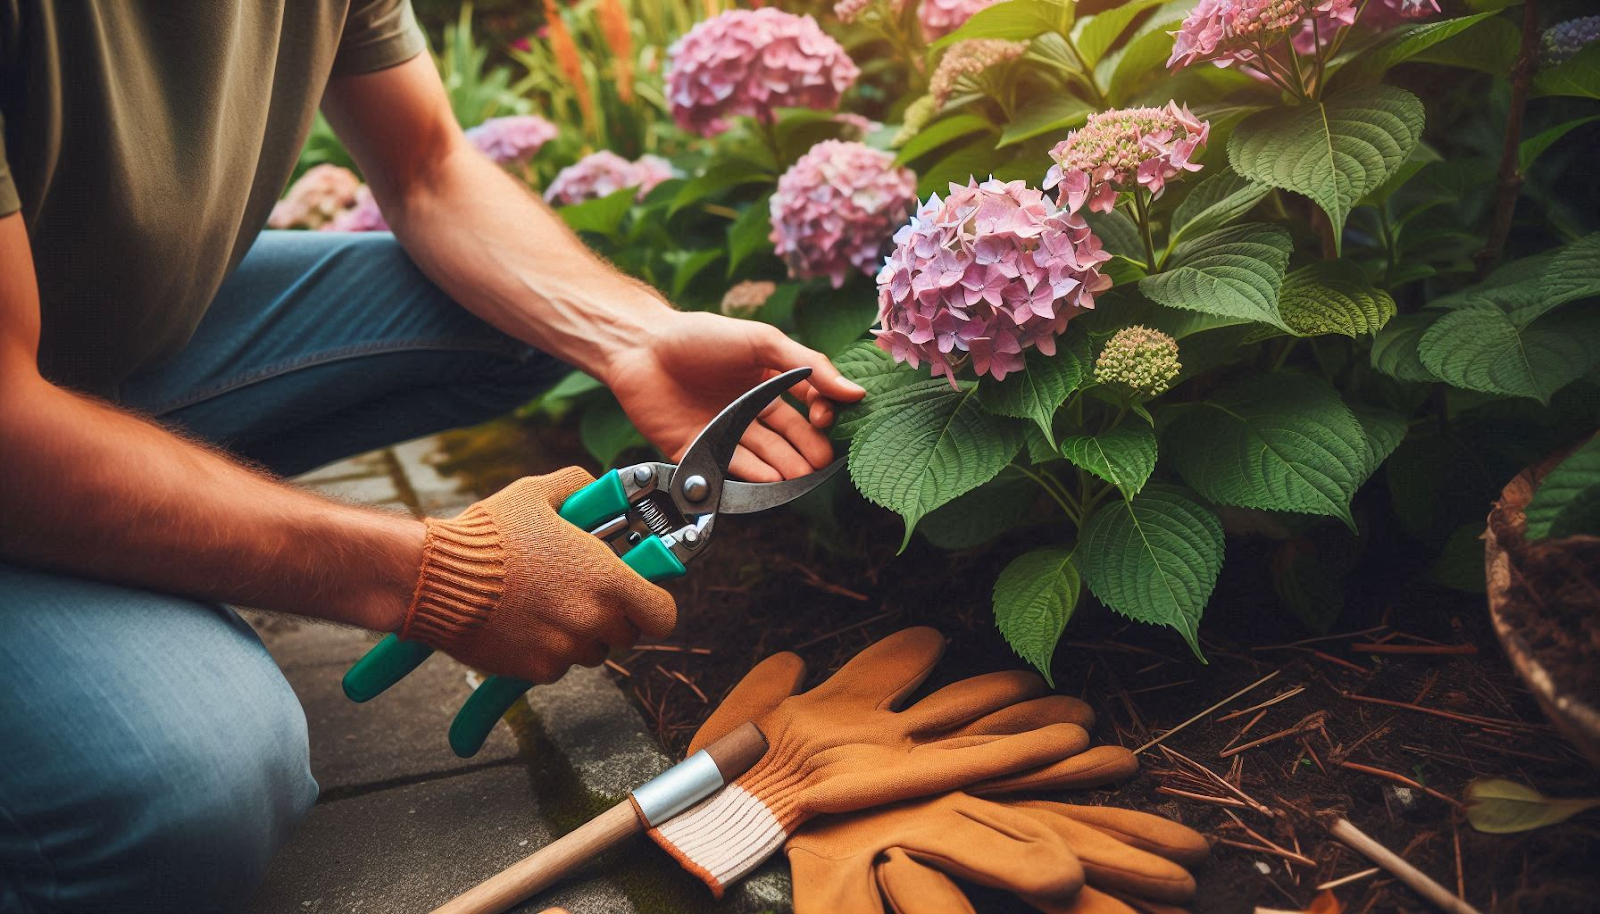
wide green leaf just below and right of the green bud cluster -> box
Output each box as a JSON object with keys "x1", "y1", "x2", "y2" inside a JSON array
[{"x1": 1166, "y1": 375, "x2": 1378, "y2": 530}]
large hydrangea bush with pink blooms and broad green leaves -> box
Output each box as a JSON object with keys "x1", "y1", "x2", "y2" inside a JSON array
[{"x1": 283, "y1": 0, "x2": 1600, "y2": 674}]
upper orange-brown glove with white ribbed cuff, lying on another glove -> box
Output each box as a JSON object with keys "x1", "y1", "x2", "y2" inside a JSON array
[{"x1": 650, "y1": 627, "x2": 1107, "y2": 896}]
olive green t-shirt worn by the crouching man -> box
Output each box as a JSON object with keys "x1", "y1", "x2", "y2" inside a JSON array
[{"x1": 0, "y1": 0, "x2": 422, "y2": 395}]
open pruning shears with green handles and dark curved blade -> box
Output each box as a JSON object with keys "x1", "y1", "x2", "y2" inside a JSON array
[{"x1": 344, "y1": 368, "x2": 843, "y2": 759}]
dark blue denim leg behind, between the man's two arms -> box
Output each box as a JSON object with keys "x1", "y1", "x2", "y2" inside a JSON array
[{"x1": 118, "y1": 232, "x2": 570, "y2": 475}]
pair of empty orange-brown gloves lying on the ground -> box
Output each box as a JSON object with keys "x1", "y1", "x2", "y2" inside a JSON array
[{"x1": 650, "y1": 627, "x2": 1210, "y2": 914}]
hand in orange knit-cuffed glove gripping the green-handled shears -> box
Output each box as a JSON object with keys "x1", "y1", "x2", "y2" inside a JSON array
[{"x1": 400, "y1": 467, "x2": 677, "y2": 682}]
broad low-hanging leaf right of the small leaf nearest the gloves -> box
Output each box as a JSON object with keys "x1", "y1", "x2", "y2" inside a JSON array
[{"x1": 1075, "y1": 485, "x2": 1222, "y2": 661}]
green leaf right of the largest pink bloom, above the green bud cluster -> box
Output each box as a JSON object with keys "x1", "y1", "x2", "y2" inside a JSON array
[{"x1": 1139, "y1": 222, "x2": 1294, "y2": 328}]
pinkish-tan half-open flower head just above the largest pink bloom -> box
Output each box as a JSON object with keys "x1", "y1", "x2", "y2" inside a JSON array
[{"x1": 1045, "y1": 101, "x2": 1211, "y2": 213}]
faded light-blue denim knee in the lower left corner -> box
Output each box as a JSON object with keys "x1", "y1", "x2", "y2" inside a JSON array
[{"x1": 0, "y1": 562, "x2": 317, "y2": 914}]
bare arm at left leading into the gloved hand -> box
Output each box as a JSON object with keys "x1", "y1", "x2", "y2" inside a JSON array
[{"x1": 0, "y1": 214, "x2": 422, "y2": 631}]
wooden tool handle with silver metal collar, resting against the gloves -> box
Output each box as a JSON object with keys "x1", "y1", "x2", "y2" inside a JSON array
[{"x1": 434, "y1": 724, "x2": 766, "y2": 914}]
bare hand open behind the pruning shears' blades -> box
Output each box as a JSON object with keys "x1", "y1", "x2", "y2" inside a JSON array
[{"x1": 603, "y1": 312, "x2": 866, "y2": 482}]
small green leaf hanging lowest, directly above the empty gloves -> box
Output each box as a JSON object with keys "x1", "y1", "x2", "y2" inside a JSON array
[{"x1": 994, "y1": 547, "x2": 1082, "y2": 688}]
